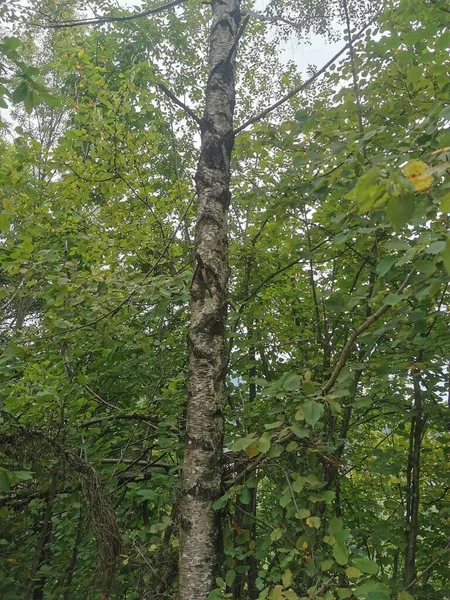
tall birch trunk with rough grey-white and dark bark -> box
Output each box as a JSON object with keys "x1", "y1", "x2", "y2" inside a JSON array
[{"x1": 179, "y1": 0, "x2": 240, "y2": 600}]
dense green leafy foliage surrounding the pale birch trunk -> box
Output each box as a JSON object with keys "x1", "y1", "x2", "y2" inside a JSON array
[{"x1": 0, "y1": 0, "x2": 450, "y2": 600}]
